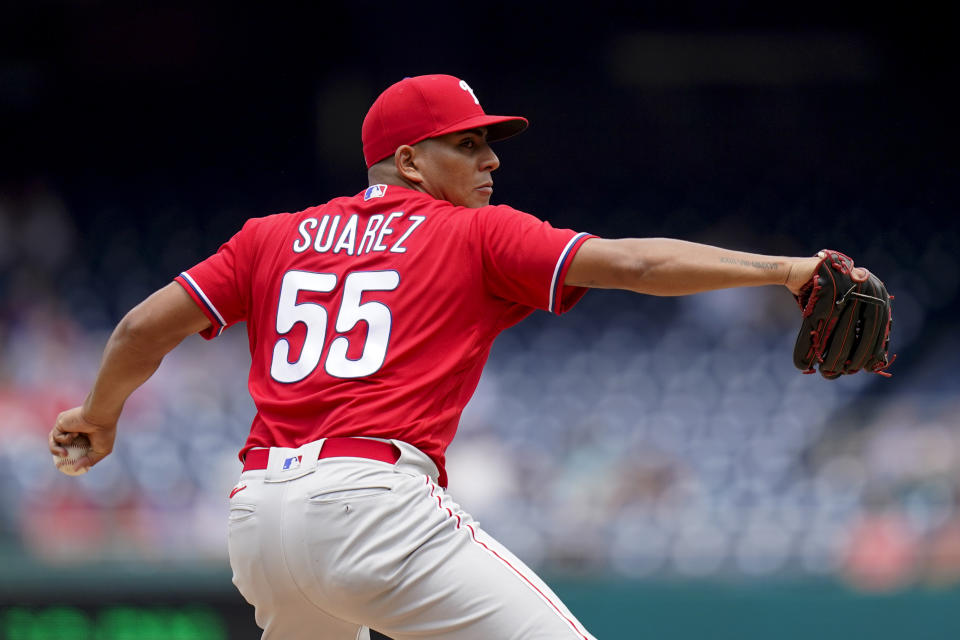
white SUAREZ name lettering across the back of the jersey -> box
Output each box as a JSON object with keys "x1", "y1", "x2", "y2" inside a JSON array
[{"x1": 293, "y1": 211, "x2": 427, "y2": 256}]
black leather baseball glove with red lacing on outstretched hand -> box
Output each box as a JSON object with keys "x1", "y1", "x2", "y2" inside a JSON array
[{"x1": 793, "y1": 249, "x2": 896, "y2": 379}]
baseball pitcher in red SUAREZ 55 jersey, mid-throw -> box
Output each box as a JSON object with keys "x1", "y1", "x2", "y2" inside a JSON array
[{"x1": 49, "y1": 75, "x2": 889, "y2": 640}]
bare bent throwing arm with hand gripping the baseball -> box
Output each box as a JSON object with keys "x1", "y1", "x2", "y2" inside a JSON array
[{"x1": 49, "y1": 282, "x2": 210, "y2": 467}]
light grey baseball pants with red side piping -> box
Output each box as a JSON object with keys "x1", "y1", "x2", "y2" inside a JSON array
[{"x1": 229, "y1": 441, "x2": 595, "y2": 640}]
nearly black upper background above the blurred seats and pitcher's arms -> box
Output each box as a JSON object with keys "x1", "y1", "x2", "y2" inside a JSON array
[{"x1": 0, "y1": 0, "x2": 960, "y2": 376}]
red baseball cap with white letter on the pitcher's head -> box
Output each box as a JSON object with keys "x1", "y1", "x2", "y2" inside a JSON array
[{"x1": 361, "y1": 75, "x2": 528, "y2": 169}]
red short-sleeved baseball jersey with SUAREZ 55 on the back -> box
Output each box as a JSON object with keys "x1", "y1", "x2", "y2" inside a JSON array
[{"x1": 176, "y1": 185, "x2": 591, "y2": 486}]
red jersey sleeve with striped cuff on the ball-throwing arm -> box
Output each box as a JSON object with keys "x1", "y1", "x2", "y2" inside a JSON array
[{"x1": 174, "y1": 220, "x2": 256, "y2": 340}]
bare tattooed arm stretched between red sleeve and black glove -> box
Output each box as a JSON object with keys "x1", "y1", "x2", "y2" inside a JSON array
[{"x1": 564, "y1": 238, "x2": 820, "y2": 296}]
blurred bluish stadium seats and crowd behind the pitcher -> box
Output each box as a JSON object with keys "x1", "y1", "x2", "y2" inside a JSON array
[{"x1": 0, "y1": 179, "x2": 960, "y2": 590}]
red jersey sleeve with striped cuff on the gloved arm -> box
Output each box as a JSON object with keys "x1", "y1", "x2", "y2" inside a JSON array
[{"x1": 478, "y1": 206, "x2": 593, "y2": 314}]
